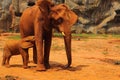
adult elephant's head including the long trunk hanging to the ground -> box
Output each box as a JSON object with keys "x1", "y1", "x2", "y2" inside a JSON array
[{"x1": 50, "y1": 4, "x2": 77, "y2": 67}]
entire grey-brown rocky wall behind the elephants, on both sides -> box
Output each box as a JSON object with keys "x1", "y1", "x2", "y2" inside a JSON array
[{"x1": 0, "y1": 0, "x2": 120, "y2": 34}]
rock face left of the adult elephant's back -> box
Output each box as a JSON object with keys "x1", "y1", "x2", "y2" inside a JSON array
[{"x1": 0, "y1": 0, "x2": 36, "y2": 32}]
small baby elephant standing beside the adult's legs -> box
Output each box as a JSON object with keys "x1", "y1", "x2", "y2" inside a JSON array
[{"x1": 2, "y1": 36, "x2": 35, "y2": 68}]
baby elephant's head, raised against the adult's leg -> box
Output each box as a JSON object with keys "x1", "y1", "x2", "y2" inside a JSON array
[{"x1": 20, "y1": 36, "x2": 35, "y2": 49}]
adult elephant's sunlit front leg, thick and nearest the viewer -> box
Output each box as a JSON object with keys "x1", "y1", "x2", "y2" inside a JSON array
[{"x1": 34, "y1": 21, "x2": 46, "y2": 71}]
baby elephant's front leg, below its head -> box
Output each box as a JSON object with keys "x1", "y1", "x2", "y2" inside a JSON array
[{"x1": 21, "y1": 49, "x2": 29, "y2": 69}]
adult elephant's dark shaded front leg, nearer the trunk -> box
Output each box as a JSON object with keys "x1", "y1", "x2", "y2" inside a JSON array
[{"x1": 44, "y1": 31, "x2": 52, "y2": 69}]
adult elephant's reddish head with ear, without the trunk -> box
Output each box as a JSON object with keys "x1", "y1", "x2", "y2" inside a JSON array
[{"x1": 50, "y1": 4, "x2": 77, "y2": 33}]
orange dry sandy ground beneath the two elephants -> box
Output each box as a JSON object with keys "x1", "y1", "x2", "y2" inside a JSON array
[{"x1": 0, "y1": 33, "x2": 120, "y2": 80}]
